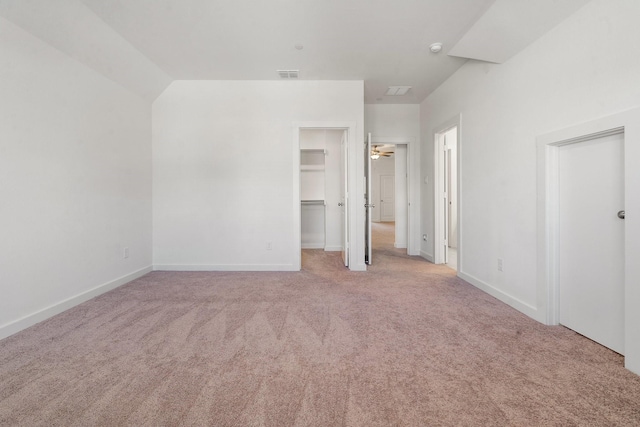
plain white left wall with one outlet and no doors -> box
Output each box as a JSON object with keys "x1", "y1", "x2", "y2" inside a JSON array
[{"x1": 0, "y1": 18, "x2": 151, "y2": 337}]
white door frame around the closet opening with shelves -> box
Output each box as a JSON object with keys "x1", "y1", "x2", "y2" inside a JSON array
[{"x1": 292, "y1": 121, "x2": 365, "y2": 270}]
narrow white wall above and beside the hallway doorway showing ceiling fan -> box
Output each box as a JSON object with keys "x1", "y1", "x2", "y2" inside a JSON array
[{"x1": 364, "y1": 104, "x2": 422, "y2": 255}]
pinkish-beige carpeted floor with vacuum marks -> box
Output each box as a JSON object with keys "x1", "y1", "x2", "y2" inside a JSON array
[{"x1": 0, "y1": 224, "x2": 640, "y2": 426}]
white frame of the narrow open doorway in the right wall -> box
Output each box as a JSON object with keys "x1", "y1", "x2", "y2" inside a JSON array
[{"x1": 433, "y1": 114, "x2": 464, "y2": 266}]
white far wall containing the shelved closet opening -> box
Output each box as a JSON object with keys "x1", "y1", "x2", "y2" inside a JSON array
[{"x1": 153, "y1": 81, "x2": 364, "y2": 270}]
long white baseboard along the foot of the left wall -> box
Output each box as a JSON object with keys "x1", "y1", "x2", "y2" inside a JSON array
[{"x1": 0, "y1": 267, "x2": 152, "y2": 339}]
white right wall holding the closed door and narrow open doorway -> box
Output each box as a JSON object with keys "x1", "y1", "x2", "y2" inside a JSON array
[{"x1": 421, "y1": 0, "x2": 640, "y2": 371}]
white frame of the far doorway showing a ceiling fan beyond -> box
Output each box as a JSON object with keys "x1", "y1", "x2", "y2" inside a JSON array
[{"x1": 371, "y1": 135, "x2": 420, "y2": 255}]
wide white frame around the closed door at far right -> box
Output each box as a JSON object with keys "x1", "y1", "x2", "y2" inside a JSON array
[{"x1": 535, "y1": 109, "x2": 640, "y2": 374}]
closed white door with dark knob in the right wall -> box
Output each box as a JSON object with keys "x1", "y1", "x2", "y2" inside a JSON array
[{"x1": 558, "y1": 133, "x2": 624, "y2": 354}]
